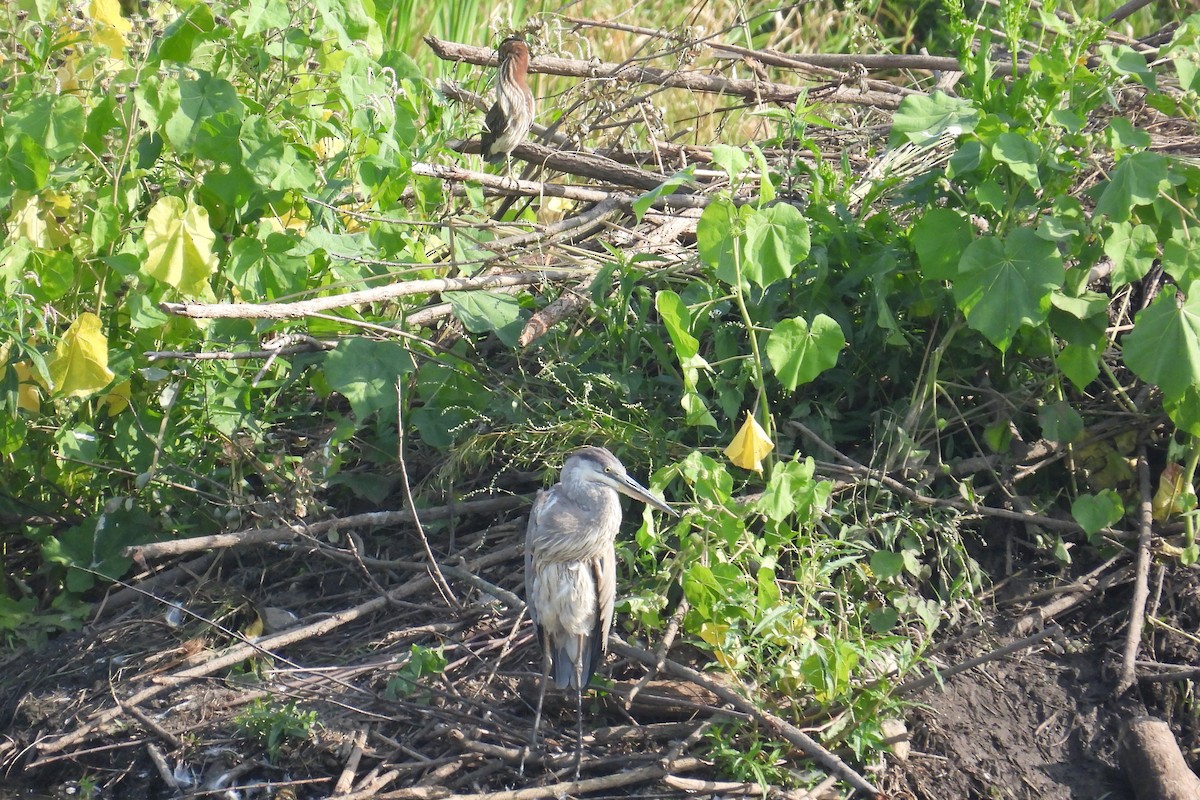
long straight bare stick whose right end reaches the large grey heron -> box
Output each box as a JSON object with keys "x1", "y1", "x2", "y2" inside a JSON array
[{"x1": 124, "y1": 495, "x2": 529, "y2": 559}]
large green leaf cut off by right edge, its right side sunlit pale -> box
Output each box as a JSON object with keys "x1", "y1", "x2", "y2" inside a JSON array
[{"x1": 1122, "y1": 288, "x2": 1200, "y2": 402}]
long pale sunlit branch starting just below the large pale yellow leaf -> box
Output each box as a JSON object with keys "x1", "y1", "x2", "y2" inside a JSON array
[{"x1": 158, "y1": 272, "x2": 578, "y2": 319}]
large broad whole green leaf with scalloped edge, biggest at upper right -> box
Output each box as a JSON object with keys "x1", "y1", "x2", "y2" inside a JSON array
[{"x1": 954, "y1": 228, "x2": 1064, "y2": 351}]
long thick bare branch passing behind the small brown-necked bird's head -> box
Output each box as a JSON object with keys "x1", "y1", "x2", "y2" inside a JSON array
[{"x1": 425, "y1": 36, "x2": 900, "y2": 109}]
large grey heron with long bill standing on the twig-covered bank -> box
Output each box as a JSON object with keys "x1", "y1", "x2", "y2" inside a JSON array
[{"x1": 526, "y1": 447, "x2": 679, "y2": 777}]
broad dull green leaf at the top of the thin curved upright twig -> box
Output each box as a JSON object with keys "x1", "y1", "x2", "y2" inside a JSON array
[{"x1": 324, "y1": 338, "x2": 413, "y2": 425}]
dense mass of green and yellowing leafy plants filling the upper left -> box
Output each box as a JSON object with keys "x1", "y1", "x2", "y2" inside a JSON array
[{"x1": 0, "y1": 0, "x2": 458, "y2": 633}]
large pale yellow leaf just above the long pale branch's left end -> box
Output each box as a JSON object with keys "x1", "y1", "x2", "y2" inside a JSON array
[{"x1": 145, "y1": 197, "x2": 217, "y2": 296}]
